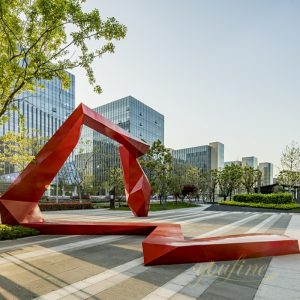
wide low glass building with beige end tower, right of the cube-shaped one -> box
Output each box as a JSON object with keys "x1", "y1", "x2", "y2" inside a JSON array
[{"x1": 172, "y1": 142, "x2": 224, "y2": 172}]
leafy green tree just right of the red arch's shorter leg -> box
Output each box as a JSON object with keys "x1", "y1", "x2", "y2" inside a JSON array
[{"x1": 140, "y1": 140, "x2": 173, "y2": 204}]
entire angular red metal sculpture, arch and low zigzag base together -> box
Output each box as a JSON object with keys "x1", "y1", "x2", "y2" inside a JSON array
[{"x1": 0, "y1": 104, "x2": 300, "y2": 265}]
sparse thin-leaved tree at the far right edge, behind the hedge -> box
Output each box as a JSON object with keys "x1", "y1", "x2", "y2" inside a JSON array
[{"x1": 278, "y1": 141, "x2": 300, "y2": 192}]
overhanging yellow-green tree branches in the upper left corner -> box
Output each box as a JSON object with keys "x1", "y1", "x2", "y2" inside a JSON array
[{"x1": 0, "y1": 0, "x2": 126, "y2": 118}]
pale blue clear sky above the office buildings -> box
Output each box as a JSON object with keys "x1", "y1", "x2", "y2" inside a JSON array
[{"x1": 73, "y1": 0, "x2": 300, "y2": 174}]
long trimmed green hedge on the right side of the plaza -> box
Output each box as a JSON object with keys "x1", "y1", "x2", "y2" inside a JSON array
[{"x1": 233, "y1": 193, "x2": 293, "y2": 204}]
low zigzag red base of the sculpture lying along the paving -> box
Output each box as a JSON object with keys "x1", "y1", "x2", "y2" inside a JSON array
[{"x1": 22, "y1": 222, "x2": 300, "y2": 266}]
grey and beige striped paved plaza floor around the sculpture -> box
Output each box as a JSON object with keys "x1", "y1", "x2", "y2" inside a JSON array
[{"x1": 0, "y1": 206, "x2": 300, "y2": 300}]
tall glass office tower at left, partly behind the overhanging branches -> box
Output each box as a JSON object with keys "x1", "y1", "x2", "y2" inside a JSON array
[{"x1": 0, "y1": 73, "x2": 75, "y2": 178}]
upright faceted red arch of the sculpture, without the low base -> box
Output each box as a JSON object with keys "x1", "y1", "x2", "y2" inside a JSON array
[{"x1": 0, "y1": 104, "x2": 151, "y2": 224}]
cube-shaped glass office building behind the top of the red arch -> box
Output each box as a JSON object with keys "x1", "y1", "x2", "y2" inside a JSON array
[{"x1": 76, "y1": 96, "x2": 164, "y2": 184}]
